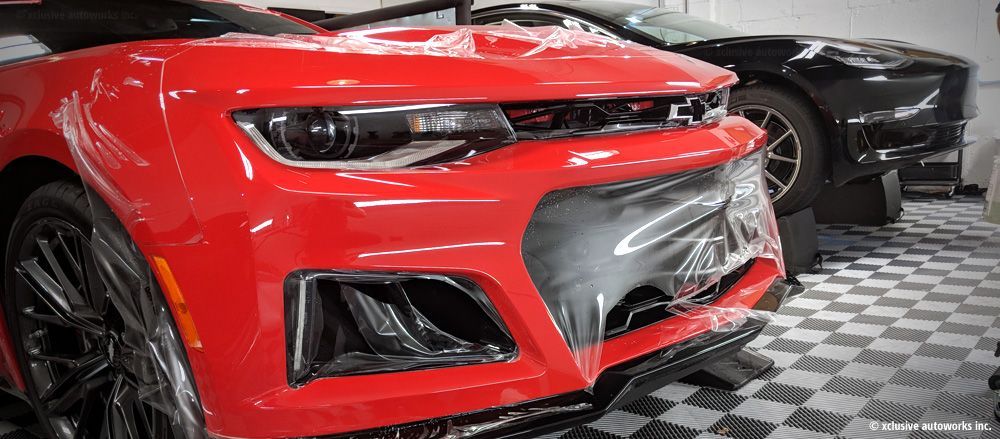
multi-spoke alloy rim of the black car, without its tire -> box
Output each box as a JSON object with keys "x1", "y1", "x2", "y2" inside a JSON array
[{"x1": 730, "y1": 105, "x2": 802, "y2": 201}]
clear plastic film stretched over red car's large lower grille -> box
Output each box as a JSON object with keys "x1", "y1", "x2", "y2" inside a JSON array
[{"x1": 522, "y1": 152, "x2": 783, "y2": 380}]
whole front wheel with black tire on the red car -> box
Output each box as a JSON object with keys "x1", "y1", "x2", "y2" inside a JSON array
[{"x1": 3, "y1": 180, "x2": 204, "y2": 439}]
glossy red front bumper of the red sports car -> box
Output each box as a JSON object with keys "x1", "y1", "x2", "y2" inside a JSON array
[{"x1": 143, "y1": 118, "x2": 782, "y2": 438}]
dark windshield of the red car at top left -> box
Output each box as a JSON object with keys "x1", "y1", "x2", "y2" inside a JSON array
[{"x1": 0, "y1": 0, "x2": 315, "y2": 65}]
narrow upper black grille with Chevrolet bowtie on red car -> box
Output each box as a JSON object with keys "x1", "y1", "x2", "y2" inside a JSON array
[{"x1": 501, "y1": 89, "x2": 729, "y2": 140}]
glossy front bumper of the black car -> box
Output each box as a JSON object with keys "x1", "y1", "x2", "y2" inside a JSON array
[{"x1": 809, "y1": 52, "x2": 979, "y2": 185}]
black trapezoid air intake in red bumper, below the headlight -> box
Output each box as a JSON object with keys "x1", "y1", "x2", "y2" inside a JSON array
[{"x1": 285, "y1": 271, "x2": 517, "y2": 386}]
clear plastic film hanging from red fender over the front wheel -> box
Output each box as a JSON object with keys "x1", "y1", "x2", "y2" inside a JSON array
[{"x1": 52, "y1": 81, "x2": 208, "y2": 439}]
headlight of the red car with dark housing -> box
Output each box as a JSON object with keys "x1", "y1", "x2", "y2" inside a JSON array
[{"x1": 233, "y1": 104, "x2": 514, "y2": 170}]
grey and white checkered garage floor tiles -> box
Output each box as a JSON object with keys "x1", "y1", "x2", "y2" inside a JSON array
[{"x1": 0, "y1": 197, "x2": 1000, "y2": 439}]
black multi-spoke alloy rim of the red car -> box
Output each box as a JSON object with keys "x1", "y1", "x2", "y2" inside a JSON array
[{"x1": 13, "y1": 218, "x2": 178, "y2": 439}]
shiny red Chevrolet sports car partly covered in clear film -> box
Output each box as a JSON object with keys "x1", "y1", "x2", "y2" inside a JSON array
[{"x1": 0, "y1": 0, "x2": 794, "y2": 438}]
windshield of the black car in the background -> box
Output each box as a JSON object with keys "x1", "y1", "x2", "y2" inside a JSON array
[{"x1": 614, "y1": 8, "x2": 744, "y2": 44}]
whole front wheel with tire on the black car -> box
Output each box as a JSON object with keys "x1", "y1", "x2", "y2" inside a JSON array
[{"x1": 729, "y1": 84, "x2": 830, "y2": 216}]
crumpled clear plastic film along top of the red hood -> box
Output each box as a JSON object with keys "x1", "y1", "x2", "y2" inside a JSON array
[{"x1": 187, "y1": 21, "x2": 634, "y2": 58}]
